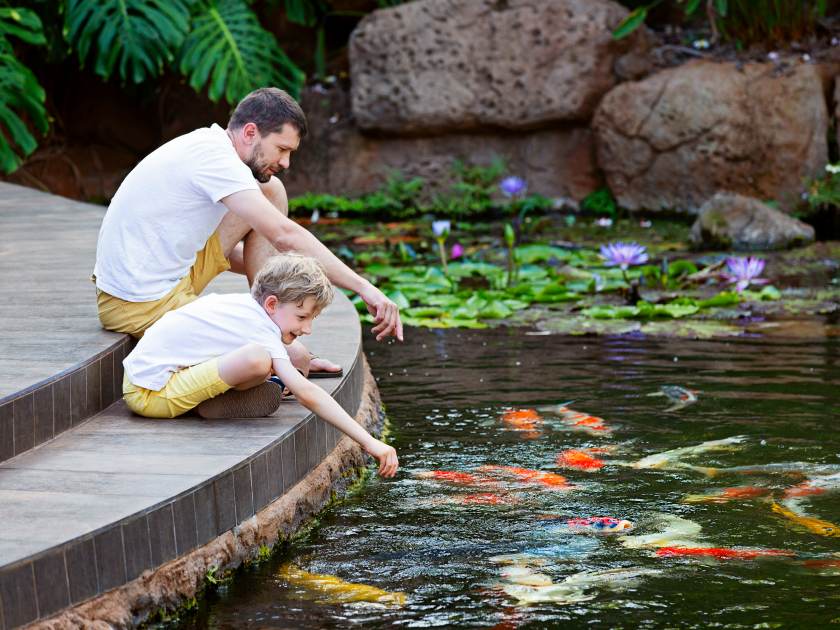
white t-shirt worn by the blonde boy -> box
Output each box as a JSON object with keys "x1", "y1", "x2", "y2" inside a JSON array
[{"x1": 123, "y1": 293, "x2": 289, "y2": 391}]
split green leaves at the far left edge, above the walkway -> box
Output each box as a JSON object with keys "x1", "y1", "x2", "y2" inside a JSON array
[{"x1": 0, "y1": 7, "x2": 49, "y2": 173}]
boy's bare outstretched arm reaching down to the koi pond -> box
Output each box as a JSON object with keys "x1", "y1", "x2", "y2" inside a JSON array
[{"x1": 272, "y1": 359, "x2": 399, "y2": 477}]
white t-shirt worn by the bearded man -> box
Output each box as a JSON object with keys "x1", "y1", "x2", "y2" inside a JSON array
[{"x1": 94, "y1": 125, "x2": 259, "y2": 302}]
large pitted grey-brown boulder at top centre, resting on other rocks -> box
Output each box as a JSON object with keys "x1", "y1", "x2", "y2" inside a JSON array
[{"x1": 350, "y1": 0, "x2": 645, "y2": 133}]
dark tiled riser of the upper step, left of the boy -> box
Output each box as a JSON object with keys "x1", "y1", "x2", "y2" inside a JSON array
[{"x1": 0, "y1": 336, "x2": 135, "y2": 462}]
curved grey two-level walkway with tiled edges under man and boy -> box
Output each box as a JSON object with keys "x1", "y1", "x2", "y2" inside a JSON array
[{"x1": 0, "y1": 184, "x2": 363, "y2": 630}]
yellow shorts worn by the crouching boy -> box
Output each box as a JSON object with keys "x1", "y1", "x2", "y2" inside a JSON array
[{"x1": 123, "y1": 359, "x2": 231, "y2": 418}]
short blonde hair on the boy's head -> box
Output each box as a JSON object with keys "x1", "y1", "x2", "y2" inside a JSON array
[{"x1": 251, "y1": 254, "x2": 334, "y2": 310}]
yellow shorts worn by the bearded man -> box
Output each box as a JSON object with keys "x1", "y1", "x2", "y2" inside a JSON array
[{"x1": 96, "y1": 232, "x2": 230, "y2": 339}]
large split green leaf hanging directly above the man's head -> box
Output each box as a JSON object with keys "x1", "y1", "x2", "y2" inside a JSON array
[{"x1": 180, "y1": 0, "x2": 304, "y2": 104}]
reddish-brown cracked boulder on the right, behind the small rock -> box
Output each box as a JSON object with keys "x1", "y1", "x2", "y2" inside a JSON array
[{"x1": 593, "y1": 61, "x2": 829, "y2": 214}]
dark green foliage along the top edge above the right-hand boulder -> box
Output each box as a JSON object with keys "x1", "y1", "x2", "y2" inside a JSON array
[{"x1": 613, "y1": 0, "x2": 827, "y2": 45}]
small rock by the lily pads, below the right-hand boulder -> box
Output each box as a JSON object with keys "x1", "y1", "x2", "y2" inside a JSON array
[{"x1": 691, "y1": 192, "x2": 814, "y2": 251}]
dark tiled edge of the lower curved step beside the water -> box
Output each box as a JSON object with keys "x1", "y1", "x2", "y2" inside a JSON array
[{"x1": 0, "y1": 344, "x2": 367, "y2": 630}]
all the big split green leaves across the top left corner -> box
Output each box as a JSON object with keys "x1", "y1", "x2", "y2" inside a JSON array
[{"x1": 0, "y1": 0, "x2": 334, "y2": 173}]
